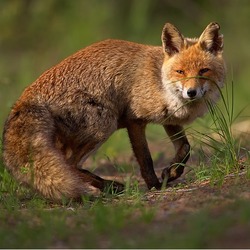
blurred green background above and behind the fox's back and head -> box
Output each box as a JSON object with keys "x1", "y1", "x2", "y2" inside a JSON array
[{"x1": 0, "y1": 0, "x2": 250, "y2": 141}]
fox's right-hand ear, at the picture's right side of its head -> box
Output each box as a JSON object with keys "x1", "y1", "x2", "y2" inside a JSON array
[{"x1": 199, "y1": 22, "x2": 223, "y2": 55}]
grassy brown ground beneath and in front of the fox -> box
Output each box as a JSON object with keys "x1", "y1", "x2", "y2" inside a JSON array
[{"x1": 0, "y1": 122, "x2": 250, "y2": 248}]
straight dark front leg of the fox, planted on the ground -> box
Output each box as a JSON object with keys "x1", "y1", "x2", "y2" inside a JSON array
[{"x1": 127, "y1": 122, "x2": 161, "y2": 189}]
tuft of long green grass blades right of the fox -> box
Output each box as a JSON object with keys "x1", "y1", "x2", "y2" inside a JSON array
[{"x1": 190, "y1": 79, "x2": 247, "y2": 184}]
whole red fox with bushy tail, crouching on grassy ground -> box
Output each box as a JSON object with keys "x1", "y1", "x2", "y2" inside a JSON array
[{"x1": 3, "y1": 22, "x2": 226, "y2": 201}]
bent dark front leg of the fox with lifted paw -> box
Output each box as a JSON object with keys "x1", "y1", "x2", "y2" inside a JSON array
[{"x1": 162, "y1": 125, "x2": 190, "y2": 182}]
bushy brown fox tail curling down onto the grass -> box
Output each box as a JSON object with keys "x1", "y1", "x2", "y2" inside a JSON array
[{"x1": 3, "y1": 106, "x2": 98, "y2": 200}]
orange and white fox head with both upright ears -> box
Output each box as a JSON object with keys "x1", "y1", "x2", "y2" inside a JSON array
[{"x1": 162, "y1": 22, "x2": 226, "y2": 102}]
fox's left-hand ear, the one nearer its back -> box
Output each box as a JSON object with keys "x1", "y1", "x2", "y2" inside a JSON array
[{"x1": 161, "y1": 23, "x2": 184, "y2": 56}]
